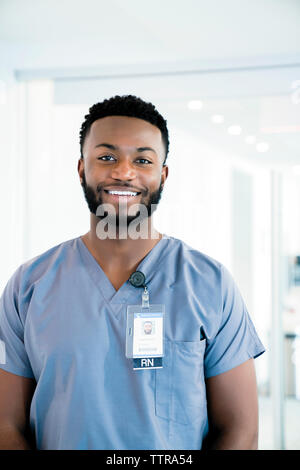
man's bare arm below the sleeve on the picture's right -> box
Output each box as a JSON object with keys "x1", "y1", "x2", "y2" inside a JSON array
[{"x1": 203, "y1": 359, "x2": 258, "y2": 450}]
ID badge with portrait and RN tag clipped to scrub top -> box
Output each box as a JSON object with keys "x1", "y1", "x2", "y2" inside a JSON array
[{"x1": 126, "y1": 305, "x2": 165, "y2": 370}]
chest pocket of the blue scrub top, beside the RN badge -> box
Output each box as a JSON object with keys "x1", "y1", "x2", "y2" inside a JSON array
[{"x1": 155, "y1": 339, "x2": 206, "y2": 424}]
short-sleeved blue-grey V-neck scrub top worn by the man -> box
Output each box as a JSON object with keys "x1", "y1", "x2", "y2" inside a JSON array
[{"x1": 0, "y1": 235, "x2": 264, "y2": 450}]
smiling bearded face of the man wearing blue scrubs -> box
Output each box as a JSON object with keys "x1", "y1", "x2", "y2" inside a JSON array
[{"x1": 78, "y1": 116, "x2": 168, "y2": 225}]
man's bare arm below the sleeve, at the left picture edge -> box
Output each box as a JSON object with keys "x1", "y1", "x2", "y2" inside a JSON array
[{"x1": 0, "y1": 369, "x2": 35, "y2": 450}]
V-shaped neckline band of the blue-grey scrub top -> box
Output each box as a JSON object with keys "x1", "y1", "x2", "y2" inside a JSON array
[{"x1": 77, "y1": 234, "x2": 171, "y2": 304}]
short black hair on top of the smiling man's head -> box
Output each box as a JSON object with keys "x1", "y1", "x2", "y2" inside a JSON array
[{"x1": 79, "y1": 95, "x2": 169, "y2": 165}]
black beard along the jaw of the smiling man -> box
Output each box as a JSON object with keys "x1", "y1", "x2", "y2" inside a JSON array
[{"x1": 81, "y1": 172, "x2": 163, "y2": 227}]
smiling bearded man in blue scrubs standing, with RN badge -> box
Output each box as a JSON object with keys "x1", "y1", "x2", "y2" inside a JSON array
[{"x1": 0, "y1": 95, "x2": 264, "y2": 450}]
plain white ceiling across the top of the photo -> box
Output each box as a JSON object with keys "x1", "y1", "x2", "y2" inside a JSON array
[{"x1": 0, "y1": 0, "x2": 300, "y2": 68}]
